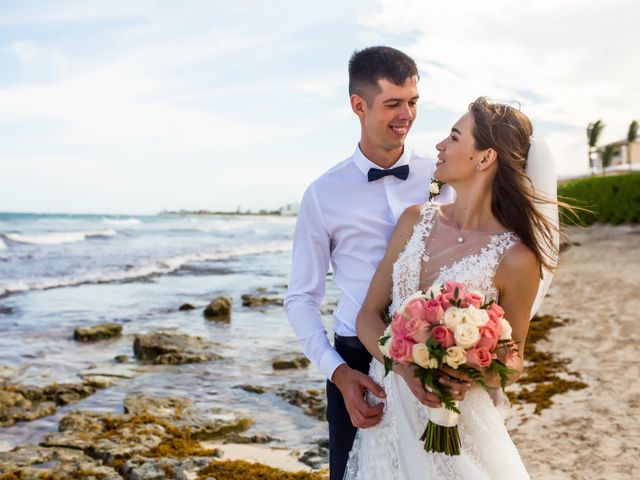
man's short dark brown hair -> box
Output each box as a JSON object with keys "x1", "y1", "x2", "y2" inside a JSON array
[{"x1": 349, "y1": 46, "x2": 420, "y2": 105}]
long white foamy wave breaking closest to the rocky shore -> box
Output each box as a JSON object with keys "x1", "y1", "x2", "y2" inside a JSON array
[{"x1": 0, "y1": 240, "x2": 291, "y2": 296}]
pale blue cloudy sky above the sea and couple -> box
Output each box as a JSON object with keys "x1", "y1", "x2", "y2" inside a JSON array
[{"x1": 0, "y1": 0, "x2": 640, "y2": 214}]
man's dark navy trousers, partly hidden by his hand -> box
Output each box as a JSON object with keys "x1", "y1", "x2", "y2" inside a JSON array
[{"x1": 327, "y1": 338, "x2": 371, "y2": 480}]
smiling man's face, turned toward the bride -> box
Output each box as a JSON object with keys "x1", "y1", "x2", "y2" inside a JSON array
[{"x1": 360, "y1": 77, "x2": 418, "y2": 155}]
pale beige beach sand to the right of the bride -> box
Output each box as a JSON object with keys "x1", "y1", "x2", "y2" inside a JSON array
[{"x1": 507, "y1": 225, "x2": 640, "y2": 480}]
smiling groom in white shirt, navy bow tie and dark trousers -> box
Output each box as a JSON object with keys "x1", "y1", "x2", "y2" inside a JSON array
[{"x1": 285, "y1": 47, "x2": 450, "y2": 480}]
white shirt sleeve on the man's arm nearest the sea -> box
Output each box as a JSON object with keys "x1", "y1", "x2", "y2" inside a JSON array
[{"x1": 284, "y1": 184, "x2": 345, "y2": 380}]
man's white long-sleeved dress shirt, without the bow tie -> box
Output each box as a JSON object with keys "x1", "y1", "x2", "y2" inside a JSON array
[{"x1": 284, "y1": 147, "x2": 451, "y2": 379}]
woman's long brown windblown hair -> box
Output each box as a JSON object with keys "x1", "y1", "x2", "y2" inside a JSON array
[{"x1": 469, "y1": 97, "x2": 560, "y2": 271}]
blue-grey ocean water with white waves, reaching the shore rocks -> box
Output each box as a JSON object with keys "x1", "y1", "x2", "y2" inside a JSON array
[{"x1": 0, "y1": 213, "x2": 330, "y2": 450}]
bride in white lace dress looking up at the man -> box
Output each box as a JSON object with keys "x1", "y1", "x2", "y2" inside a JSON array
[{"x1": 344, "y1": 97, "x2": 558, "y2": 480}]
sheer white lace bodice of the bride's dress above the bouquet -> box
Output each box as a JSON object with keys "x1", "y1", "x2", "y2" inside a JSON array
[{"x1": 389, "y1": 203, "x2": 518, "y2": 313}]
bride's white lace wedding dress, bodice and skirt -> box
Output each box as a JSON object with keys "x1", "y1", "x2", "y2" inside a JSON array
[{"x1": 344, "y1": 204, "x2": 529, "y2": 480}]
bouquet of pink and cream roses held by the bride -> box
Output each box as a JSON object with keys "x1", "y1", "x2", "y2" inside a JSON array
[{"x1": 379, "y1": 282, "x2": 517, "y2": 455}]
